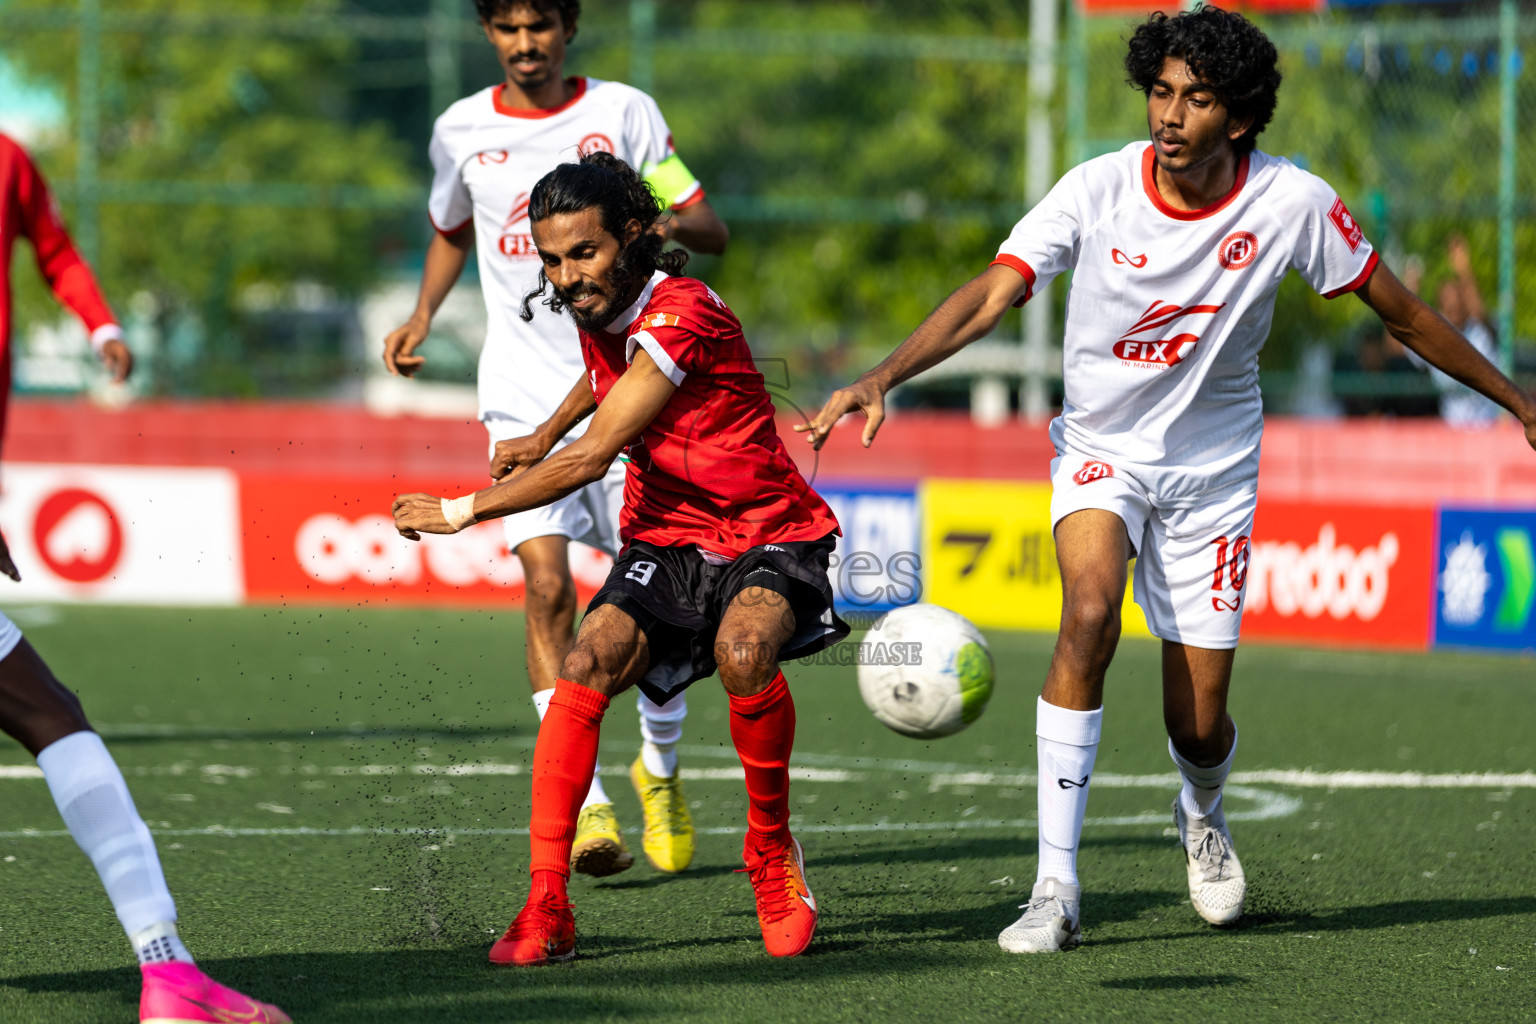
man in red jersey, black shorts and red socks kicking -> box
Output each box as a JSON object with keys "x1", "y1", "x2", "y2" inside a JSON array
[{"x1": 395, "y1": 152, "x2": 848, "y2": 966}]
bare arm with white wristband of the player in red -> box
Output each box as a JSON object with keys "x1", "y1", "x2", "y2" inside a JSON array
[{"x1": 393, "y1": 348, "x2": 677, "y2": 540}]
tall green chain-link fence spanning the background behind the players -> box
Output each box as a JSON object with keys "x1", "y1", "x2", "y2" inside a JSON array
[{"x1": 0, "y1": 0, "x2": 1536, "y2": 411}]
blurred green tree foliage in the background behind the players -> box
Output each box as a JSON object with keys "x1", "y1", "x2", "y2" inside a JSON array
[{"x1": 8, "y1": 0, "x2": 1536, "y2": 401}]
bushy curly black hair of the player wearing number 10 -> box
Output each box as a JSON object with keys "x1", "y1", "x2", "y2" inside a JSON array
[{"x1": 1126, "y1": 6, "x2": 1279, "y2": 154}]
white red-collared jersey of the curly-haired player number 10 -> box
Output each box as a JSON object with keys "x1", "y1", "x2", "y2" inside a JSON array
[{"x1": 997, "y1": 143, "x2": 1376, "y2": 507}]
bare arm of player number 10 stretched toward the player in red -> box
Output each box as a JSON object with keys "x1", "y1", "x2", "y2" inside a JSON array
[{"x1": 796, "y1": 264, "x2": 1031, "y2": 448}]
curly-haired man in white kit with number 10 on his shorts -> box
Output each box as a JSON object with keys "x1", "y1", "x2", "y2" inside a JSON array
[{"x1": 802, "y1": 6, "x2": 1536, "y2": 953}]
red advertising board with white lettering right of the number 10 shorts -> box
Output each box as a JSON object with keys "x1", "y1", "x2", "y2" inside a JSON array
[{"x1": 1243, "y1": 499, "x2": 1435, "y2": 649}]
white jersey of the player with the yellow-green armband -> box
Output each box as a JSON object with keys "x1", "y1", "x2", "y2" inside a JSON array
[{"x1": 429, "y1": 78, "x2": 703, "y2": 438}]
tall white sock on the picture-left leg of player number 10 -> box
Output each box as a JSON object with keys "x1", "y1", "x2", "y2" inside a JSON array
[{"x1": 1035, "y1": 697, "x2": 1104, "y2": 886}]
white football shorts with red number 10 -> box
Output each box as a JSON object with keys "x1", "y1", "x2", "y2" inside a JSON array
[{"x1": 1051, "y1": 451, "x2": 1258, "y2": 649}]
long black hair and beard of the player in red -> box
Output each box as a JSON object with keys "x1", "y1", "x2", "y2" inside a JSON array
[{"x1": 521, "y1": 150, "x2": 688, "y2": 321}]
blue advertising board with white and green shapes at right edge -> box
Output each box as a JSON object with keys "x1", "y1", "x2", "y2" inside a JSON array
[{"x1": 1435, "y1": 508, "x2": 1536, "y2": 651}]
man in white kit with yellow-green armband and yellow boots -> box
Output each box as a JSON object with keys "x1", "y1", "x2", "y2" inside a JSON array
[{"x1": 384, "y1": 0, "x2": 728, "y2": 875}]
